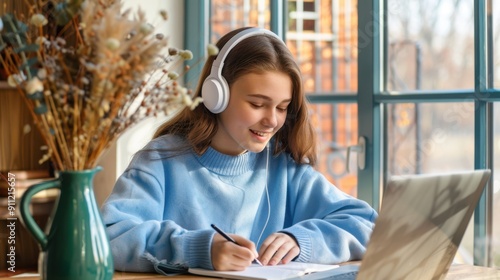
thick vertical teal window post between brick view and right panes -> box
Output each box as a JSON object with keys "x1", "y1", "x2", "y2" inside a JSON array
[{"x1": 358, "y1": 0, "x2": 383, "y2": 209}]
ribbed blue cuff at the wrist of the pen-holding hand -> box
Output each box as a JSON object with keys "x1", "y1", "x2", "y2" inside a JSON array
[{"x1": 184, "y1": 230, "x2": 215, "y2": 269}]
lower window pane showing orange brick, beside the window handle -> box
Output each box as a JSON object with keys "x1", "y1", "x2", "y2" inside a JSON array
[{"x1": 311, "y1": 104, "x2": 358, "y2": 196}]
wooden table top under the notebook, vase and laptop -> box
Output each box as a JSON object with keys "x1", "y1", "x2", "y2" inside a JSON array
[{"x1": 0, "y1": 264, "x2": 500, "y2": 280}]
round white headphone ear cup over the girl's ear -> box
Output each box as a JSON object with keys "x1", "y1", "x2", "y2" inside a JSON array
[{"x1": 201, "y1": 76, "x2": 229, "y2": 114}]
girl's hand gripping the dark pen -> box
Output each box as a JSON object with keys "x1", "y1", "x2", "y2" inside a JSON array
[{"x1": 211, "y1": 233, "x2": 259, "y2": 270}]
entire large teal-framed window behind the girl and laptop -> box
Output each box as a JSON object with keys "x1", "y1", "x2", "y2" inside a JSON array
[{"x1": 186, "y1": 0, "x2": 500, "y2": 267}]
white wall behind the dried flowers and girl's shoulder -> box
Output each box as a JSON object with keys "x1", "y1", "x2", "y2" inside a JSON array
[{"x1": 94, "y1": 0, "x2": 184, "y2": 205}]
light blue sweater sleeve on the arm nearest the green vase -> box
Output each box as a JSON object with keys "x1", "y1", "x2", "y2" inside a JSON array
[{"x1": 102, "y1": 167, "x2": 214, "y2": 274}]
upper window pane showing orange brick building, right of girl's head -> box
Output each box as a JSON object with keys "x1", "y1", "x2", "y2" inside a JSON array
[{"x1": 286, "y1": 0, "x2": 358, "y2": 94}]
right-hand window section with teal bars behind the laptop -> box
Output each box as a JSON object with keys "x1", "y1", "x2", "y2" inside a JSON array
[{"x1": 381, "y1": 0, "x2": 500, "y2": 266}]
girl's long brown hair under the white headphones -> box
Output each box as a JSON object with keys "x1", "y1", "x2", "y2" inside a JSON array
[{"x1": 153, "y1": 27, "x2": 317, "y2": 166}]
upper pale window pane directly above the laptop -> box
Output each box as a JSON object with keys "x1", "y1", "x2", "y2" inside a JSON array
[{"x1": 386, "y1": 0, "x2": 474, "y2": 91}]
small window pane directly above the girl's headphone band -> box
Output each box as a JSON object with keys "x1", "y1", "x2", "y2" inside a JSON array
[{"x1": 210, "y1": 0, "x2": 271, "y2": 43}]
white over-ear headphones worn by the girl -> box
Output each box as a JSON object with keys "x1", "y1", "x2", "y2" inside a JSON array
[{"x1": 201, "y1": 28, "x2": 284, "y2": 114}]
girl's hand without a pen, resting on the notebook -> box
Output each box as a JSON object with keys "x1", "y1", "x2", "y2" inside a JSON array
[{"x1": 259, "y1": 232, "x2": 300, "y2": 265}]
